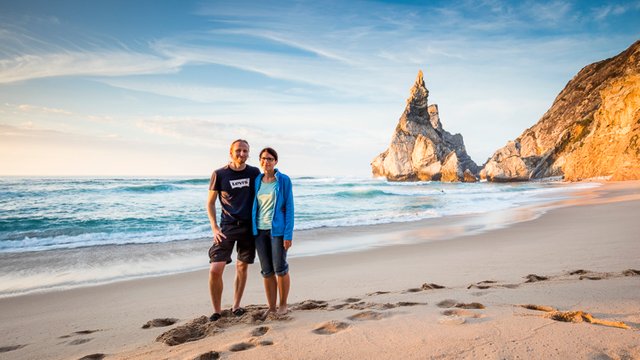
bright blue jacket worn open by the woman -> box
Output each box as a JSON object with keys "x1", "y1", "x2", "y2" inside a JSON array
[{"x1": 251, "y1": 169, "x2": 293, "y2": 240}]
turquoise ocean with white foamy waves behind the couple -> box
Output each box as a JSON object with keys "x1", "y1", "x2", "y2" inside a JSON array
[{"x1": 0, "y1": 177, "x2": 597, "y2": 296}]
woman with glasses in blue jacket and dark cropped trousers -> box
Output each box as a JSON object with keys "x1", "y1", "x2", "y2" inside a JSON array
[{"x1": 252, "y1": 147, "x2": 293, "y2": 315}]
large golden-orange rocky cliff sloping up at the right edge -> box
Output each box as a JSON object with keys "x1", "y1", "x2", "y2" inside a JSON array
[{"x1": 480, "y1": 41, "x2": 640, "y2": 181}]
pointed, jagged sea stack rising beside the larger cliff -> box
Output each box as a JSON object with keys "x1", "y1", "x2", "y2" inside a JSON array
[{"x1": 371, "y1": 71, "x2": 478, "y2": 181}]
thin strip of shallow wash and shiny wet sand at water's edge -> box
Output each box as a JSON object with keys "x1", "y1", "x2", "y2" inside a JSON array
[{"x1": 0, "y1": 183, "x2": 601, "y2": 299}]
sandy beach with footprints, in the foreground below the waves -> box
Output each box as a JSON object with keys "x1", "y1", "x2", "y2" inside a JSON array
[{"x1": 0, "y1": 181, "x2": 640, "y2": 359}]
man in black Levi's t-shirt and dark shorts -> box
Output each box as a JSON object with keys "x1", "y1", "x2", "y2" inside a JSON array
[{"x1": 207, "y1": 139, "x2": 260, "y2": 321}]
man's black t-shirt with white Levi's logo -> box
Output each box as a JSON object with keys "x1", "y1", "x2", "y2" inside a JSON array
[{"x1": 209, "y1": 165, "x2": 260, "y2": 224}]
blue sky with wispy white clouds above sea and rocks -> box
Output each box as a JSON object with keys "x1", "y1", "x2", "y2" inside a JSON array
[{"x1": 0, "y1": 0, "x2": 640, "y2": 176}]
